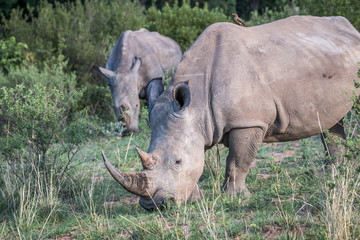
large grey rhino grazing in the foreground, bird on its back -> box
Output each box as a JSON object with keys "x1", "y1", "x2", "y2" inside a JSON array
[{"x1": 103, "y1": 16, "x2": 360, "y2": 210}]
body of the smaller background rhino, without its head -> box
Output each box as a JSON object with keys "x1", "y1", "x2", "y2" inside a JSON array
[{"x1": 106, "y1": 29, "x2": 182, "y2": 81}]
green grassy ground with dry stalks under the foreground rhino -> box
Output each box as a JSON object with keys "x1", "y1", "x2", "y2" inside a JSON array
[{"x1": 0, "y1": 122, "x2": 360, "y2": 239}]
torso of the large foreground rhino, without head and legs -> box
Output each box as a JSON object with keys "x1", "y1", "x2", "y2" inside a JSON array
[{"x1": 174, "y1": 16, "x2": 360, "y2": 144}]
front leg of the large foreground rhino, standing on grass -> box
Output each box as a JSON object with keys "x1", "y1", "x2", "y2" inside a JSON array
[{"x1": 222, "y1": 128, "x2": 264, "y2": 195}]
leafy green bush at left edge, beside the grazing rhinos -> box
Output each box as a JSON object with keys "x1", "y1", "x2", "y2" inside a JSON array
[{"x1": 0, "y1": 62, "x2": 89, "y2": 191}]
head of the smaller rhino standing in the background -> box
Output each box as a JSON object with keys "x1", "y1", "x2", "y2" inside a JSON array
[{"x1": 94, "y1": 58, "x2": 141, "y2": 134}]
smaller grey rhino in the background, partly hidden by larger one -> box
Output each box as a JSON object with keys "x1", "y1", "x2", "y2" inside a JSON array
[{"x1": 94, "y1": 28, "x2": 182, "y2": 133}]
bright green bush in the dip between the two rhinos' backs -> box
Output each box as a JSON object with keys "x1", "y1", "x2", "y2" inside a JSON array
[{"x1": 146, "y1": 2, "x2": 230, "y2": 51}]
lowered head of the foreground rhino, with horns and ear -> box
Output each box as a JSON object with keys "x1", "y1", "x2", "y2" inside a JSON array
[{"x1": 103, "y1": 83, "x2": 205, "y2": 210}]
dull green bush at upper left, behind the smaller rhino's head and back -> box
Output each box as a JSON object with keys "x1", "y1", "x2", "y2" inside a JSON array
[{"x1": 3, "y1": 0, "x2": 144, "y2": 82}]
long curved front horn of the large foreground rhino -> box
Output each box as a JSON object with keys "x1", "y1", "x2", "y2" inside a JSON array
[{"x1": 101, "y1": 151, "x2": 152, "y2": 197}]
